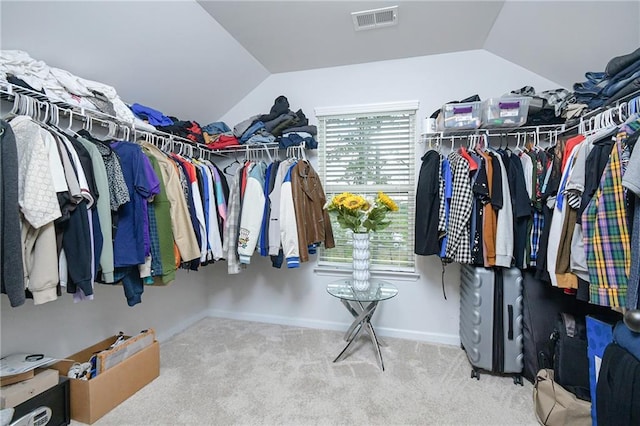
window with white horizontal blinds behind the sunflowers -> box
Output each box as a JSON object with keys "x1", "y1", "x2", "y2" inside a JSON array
[{"x1": 316, "y1": 102, "x2": 418, "y2": 272}]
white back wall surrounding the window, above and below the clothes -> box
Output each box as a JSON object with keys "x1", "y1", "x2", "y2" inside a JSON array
[{"x1": 210, "y1": 50, "x2": 558, "y2": 344}]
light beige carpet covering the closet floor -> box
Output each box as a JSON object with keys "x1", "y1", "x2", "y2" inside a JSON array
[{"x1": 82, "y1": 318, "x2": 537, "y2": 426}]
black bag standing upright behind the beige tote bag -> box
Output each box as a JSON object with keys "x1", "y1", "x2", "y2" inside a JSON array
[{"x1": 551, "y1": 313, "x2": 591, "y2": 401}]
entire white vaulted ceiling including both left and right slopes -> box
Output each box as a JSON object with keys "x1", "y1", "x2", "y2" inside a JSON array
[{"x1": 0, "y1": 0, "x2": 640, "y2": 122}]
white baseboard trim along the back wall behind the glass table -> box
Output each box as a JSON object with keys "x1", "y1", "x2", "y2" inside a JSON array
[{"x1": 208, "y1": 309, "x2": 460, "y2": 346}]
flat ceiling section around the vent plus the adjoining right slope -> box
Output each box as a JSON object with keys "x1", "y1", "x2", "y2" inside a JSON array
[{"x1": 199, "y1": 0, "x2": 640, "y2": 87}]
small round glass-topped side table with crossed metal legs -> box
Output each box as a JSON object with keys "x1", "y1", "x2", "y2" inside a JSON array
[{"x1": 327, "y1": 279, "x2": 398, "y2": 371}]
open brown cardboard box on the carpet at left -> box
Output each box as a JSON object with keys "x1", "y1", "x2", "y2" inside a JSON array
[{"x1": 51, "y1": 336, "x2": 160, "y2": 424}]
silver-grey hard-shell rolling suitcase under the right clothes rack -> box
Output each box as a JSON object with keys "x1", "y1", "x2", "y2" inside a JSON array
[{"x1": 460, "y1": 265, "x2": 523, "y2": 384}]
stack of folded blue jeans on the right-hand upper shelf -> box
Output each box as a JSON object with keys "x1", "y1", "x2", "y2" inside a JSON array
[{"x1": 573, "y1": 48, "x2": 640, "y2": 109}]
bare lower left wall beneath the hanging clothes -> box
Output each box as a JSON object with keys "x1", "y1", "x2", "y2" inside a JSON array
[{"x1": 0, "y1": 272, "x2": 210, "y2": 357}]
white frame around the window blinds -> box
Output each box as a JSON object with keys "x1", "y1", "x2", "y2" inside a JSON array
[{"x1": 315, "y1": 101, "x2": 419, "y2": 280}]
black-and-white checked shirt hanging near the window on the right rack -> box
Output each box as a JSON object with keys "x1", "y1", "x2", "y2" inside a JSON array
[{"x1": 444, "y1": 152, "x2": 473, "y2": 264}]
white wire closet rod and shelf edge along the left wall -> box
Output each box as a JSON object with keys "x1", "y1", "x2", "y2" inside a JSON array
[{"x1": 0, "y1": 80, "x2": 278, "y2": 156}]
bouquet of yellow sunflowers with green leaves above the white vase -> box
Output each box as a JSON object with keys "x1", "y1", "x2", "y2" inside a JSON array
[{"x1": 327, "y1": 192, "x2": 398, "y2": 233}]
